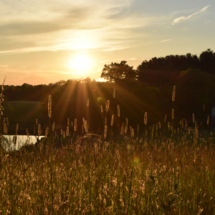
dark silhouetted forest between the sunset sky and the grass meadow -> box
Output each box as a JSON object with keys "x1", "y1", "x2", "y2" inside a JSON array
[{"x1": 1, "y1": 49, "x2": 215, "y2": 133}]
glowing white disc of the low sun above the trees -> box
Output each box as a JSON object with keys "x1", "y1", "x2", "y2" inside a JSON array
[{"x1": 68, "y1": 54, "x2": 92, "y2": 73}]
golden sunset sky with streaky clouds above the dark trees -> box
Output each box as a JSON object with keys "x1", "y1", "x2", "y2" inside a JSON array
[{"x1": 0, "y1": 0, "x2": 215, "y2": 85}]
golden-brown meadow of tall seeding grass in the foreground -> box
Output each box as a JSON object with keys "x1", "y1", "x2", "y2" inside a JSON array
[{"x1": 0, "y1": 86, "x2": 215, "y2": 215}]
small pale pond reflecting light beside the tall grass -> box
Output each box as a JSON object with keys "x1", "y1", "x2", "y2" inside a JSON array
[{"x1": 1, "y1": 135, "x2": 45, "y2": 151}]
